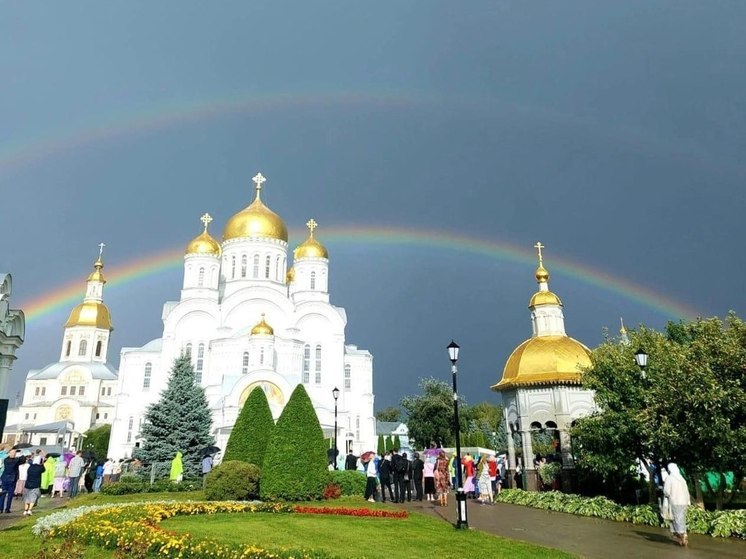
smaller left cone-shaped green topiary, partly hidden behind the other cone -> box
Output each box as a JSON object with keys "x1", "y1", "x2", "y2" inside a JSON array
[{"x1": 223, "y1": 388, "x2": 275, "y2": 467}]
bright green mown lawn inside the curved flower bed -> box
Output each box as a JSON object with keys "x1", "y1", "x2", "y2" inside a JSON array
[{"x1": 160, "y1": 513, "x2": 573, "y2": 559}]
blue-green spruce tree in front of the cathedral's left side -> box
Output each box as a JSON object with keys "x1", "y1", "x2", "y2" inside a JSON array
[{"x1": 133, "y1": 355, "x2": 213, "y2": 477}]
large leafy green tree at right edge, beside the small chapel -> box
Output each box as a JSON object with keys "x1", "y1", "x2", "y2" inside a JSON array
[{"x1": 573, "y1": 313, "x2": 746, "y2": 505}]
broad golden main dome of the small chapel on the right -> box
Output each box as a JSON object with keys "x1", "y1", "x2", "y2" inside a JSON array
[{"x1": 492, "y1": 336, "x2": 591, "y2": 391}]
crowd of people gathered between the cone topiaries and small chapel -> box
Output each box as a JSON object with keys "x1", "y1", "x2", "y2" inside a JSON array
[{"x1": 345, "y1": 445, "x2": 506, "y2": 506}]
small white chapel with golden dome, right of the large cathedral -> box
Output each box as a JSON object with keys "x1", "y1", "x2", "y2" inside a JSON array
[{"x1": 492, "y1": 243, "x2": 595, "y2": 490}]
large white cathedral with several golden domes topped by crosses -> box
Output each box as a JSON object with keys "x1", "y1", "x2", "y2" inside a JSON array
[{"x1": 109, "y1": 174, "x2": 376, "y2": 458}]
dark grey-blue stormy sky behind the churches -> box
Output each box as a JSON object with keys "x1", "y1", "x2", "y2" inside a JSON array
[{"x1": 0, "y1": 0, "x2": 746, "y2": 408}]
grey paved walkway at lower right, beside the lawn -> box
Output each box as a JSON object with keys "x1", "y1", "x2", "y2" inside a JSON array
[{"x1": 399, "y1": 499, "x2": 746, "y2": 559}]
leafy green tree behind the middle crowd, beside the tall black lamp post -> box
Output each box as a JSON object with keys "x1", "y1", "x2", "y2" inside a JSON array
[{"x1": 401, "y1": 378, "x2": 466, "y2": 447}]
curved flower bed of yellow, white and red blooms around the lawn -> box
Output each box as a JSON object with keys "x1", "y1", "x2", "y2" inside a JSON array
[{"x1": 33, "y1": 501, "x2": 406, "y2": 559}]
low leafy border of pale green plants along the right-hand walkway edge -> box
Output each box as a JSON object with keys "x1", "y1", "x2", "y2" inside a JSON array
[{"x1": 497, "y1": 489, "x2": 746, "y2": 539}]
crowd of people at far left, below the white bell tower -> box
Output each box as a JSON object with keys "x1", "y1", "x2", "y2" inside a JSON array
[{"x1": 0, "y1": 449, "x2": 132, "y2": 515}]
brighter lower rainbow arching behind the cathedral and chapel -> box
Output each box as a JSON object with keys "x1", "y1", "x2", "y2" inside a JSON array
[{"x1": 20, "y1": 226, "x2": 700, "y2": 325}]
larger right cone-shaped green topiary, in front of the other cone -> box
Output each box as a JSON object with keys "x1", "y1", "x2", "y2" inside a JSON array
[{"x1": 259, "y1": 384, "x2": 328, "y2": 501}]
